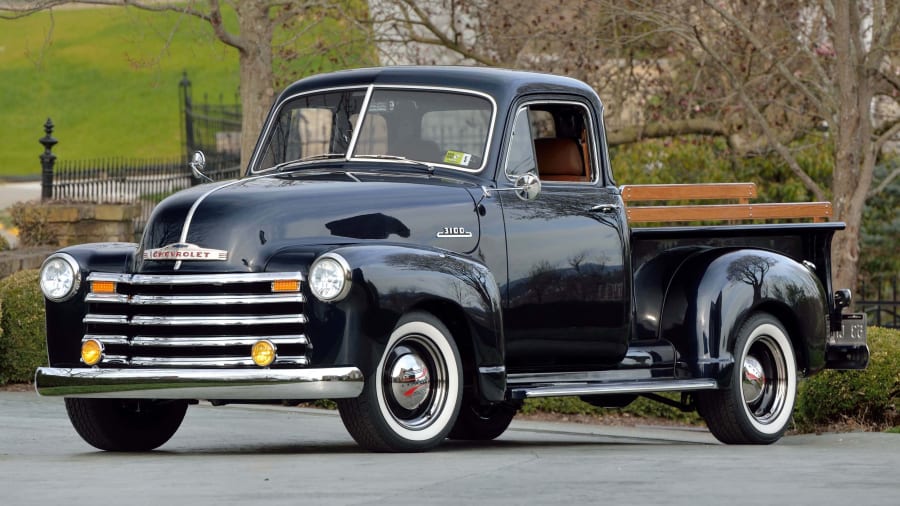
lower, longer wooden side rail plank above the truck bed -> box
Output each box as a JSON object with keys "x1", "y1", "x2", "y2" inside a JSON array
[{"x1": 625, "y1": 202, "x2": 831, "y2": 223}]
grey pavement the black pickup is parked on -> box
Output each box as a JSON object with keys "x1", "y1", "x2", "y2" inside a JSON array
[{"x1": 0, "y1": 392, "x2": 900, "y2": 506}]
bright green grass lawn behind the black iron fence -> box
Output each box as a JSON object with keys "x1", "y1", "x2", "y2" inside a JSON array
[{"x1": 0, "y1": 3, "x2": 374, "y2": 178}]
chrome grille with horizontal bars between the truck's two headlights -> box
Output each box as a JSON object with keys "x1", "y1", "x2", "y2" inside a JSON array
[{"x1": 84, "y1": 272, "x2": 312, "y2": 368}]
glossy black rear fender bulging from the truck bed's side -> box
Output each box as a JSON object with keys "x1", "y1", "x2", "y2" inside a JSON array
[{"x1": 660, "y1": 249, "x2": 827, "y2": 386}]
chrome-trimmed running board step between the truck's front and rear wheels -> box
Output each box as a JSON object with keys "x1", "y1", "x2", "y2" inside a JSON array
[{"x1": 510, "y1": 379, "x2": 719, "y2": 400}]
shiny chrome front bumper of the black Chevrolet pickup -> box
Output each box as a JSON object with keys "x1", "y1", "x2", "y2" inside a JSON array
[{"x1": 34, "y1": 367, "x2": 363, "y2": 400}]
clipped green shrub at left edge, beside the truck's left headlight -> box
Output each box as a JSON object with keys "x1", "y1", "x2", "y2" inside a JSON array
[{"x1": 0, "y1": 269, "x2": 47, "y2": 384}]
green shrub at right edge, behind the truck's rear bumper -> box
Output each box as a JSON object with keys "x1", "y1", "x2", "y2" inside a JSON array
[{"x1": 794, "y1": 327, "x2": 900, "y2": 431}]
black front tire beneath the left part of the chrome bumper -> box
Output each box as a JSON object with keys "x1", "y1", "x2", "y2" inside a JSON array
[{"x1": 66, "y1": 398, "x2": 188, "y2": 452}]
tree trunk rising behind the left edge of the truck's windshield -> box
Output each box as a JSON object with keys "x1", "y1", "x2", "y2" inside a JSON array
[{"x1": 235, "y1": 0, "x2": 275, "y2": 168}]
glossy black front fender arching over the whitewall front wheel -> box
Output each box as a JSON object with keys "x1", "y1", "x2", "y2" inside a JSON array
[{"x1": 310, "y1": 245, "x2": 506, "y2": 401}]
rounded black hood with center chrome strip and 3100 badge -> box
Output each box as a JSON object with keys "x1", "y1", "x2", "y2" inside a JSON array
[{"x1": 136, "y1": 172, "x2": 479, "y2": 272}]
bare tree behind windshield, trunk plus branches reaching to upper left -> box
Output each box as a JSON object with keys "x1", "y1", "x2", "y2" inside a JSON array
[{"x1": 0, "y1": 0, "x2": 370, "y2": 165}]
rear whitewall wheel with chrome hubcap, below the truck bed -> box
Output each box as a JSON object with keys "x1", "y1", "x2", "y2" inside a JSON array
[{"x1": 697, "y1": 313, "x2": 797, "y2": 444}]
